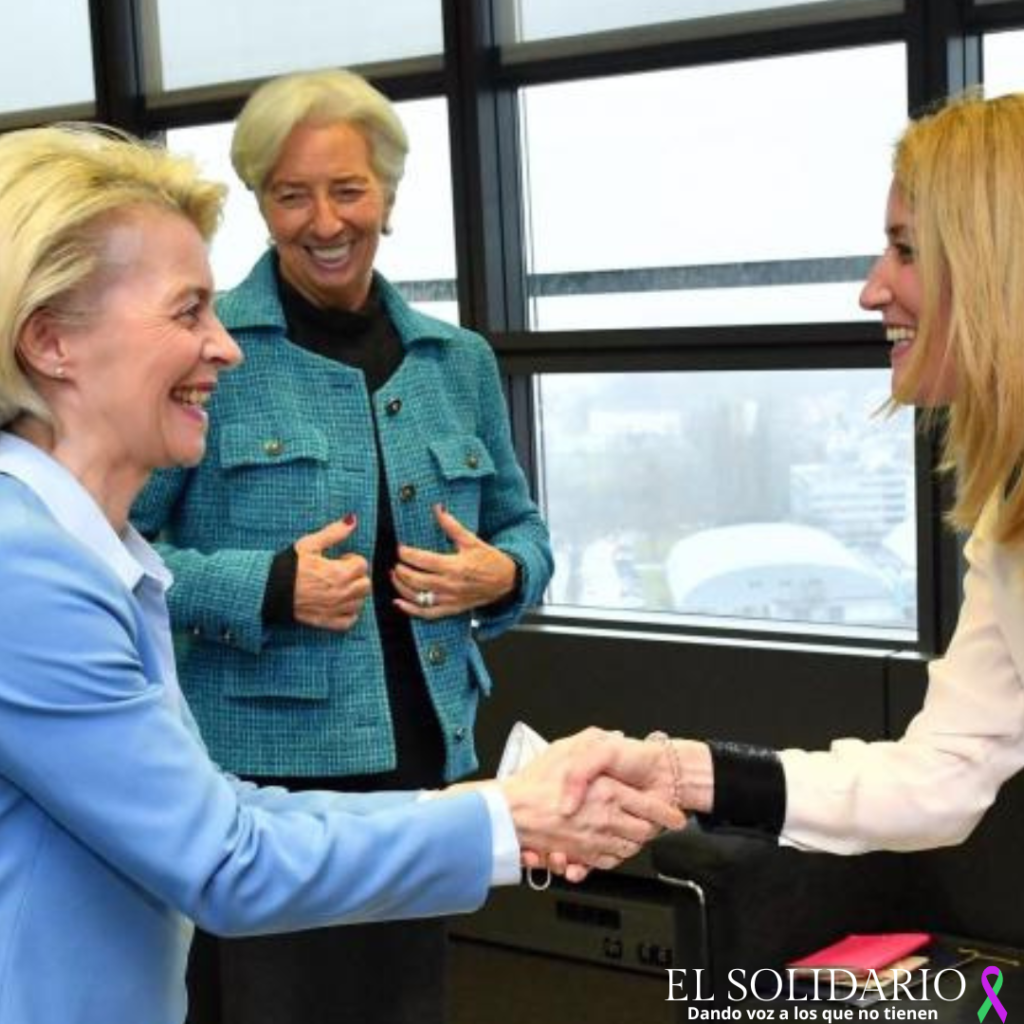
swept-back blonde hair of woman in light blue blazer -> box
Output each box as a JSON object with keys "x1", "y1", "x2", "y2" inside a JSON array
[{"x1": 0, "y1": 124, "x2": 225, "y2": 426}]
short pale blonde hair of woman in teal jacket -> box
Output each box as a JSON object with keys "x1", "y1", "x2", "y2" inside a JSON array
[{"x1": 231, "y1": 70, "x2": 409, "y2": 206}]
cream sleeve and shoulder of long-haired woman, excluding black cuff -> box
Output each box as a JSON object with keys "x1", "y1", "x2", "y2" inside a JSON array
[{"x1": 780, "y1": 507, "x2": 1024, "y2": 853}]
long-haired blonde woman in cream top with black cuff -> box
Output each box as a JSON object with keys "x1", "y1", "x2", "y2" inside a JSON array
[{"x1": 585, "y1": 94, "x2": 1024, "y2": 853}]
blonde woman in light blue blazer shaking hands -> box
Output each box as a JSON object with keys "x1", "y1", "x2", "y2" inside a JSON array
[{"x1": 0, "y1": 128, "x2": 679, "y2": 1024}]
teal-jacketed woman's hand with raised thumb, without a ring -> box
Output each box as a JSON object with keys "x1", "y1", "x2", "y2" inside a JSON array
[{"x1": 294, "y1": 514, "x2": 370, "y2": 633}]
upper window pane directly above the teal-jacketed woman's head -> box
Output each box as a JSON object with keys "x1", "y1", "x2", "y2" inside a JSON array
[{"x1": 146, "y1": 0, "x2": 442, "y2": 92}]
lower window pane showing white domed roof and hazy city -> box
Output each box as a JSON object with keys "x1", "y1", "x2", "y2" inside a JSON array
[{"x1": 537, "y1": 371, "x2": 916, "y2": 631}]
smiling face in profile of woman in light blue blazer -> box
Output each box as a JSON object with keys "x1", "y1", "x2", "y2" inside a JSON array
[{"x1": 45, "y1": 207, "x2": 241, "y2": 503}]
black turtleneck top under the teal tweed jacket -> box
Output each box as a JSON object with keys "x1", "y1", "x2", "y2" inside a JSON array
[{"x1": 253, "y1": 266, "x2": 444, "y2": 792}]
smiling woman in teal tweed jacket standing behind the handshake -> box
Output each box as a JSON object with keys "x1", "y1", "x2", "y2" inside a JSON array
[{"x1": 133, "y1": 71, "x2": 552, "y2": 1024}]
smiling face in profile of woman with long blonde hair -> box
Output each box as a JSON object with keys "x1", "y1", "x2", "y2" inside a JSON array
[{"x1": 860, "y1": 182, "x2": 956, "y2": 407}]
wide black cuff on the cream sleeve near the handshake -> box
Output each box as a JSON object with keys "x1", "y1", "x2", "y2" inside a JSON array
[{"x1": 708, "y1": 740, "x2": 785, "y2": 836}]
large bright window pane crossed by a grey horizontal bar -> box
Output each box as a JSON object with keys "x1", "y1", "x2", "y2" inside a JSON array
[{"x1": 521, "y1": 45, "x2": 906, "y2": 328}]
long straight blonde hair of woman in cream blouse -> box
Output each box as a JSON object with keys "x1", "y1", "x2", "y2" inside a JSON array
[{"x1": 894, "y1": 93, "x2": 1024, "y2": 544}]
